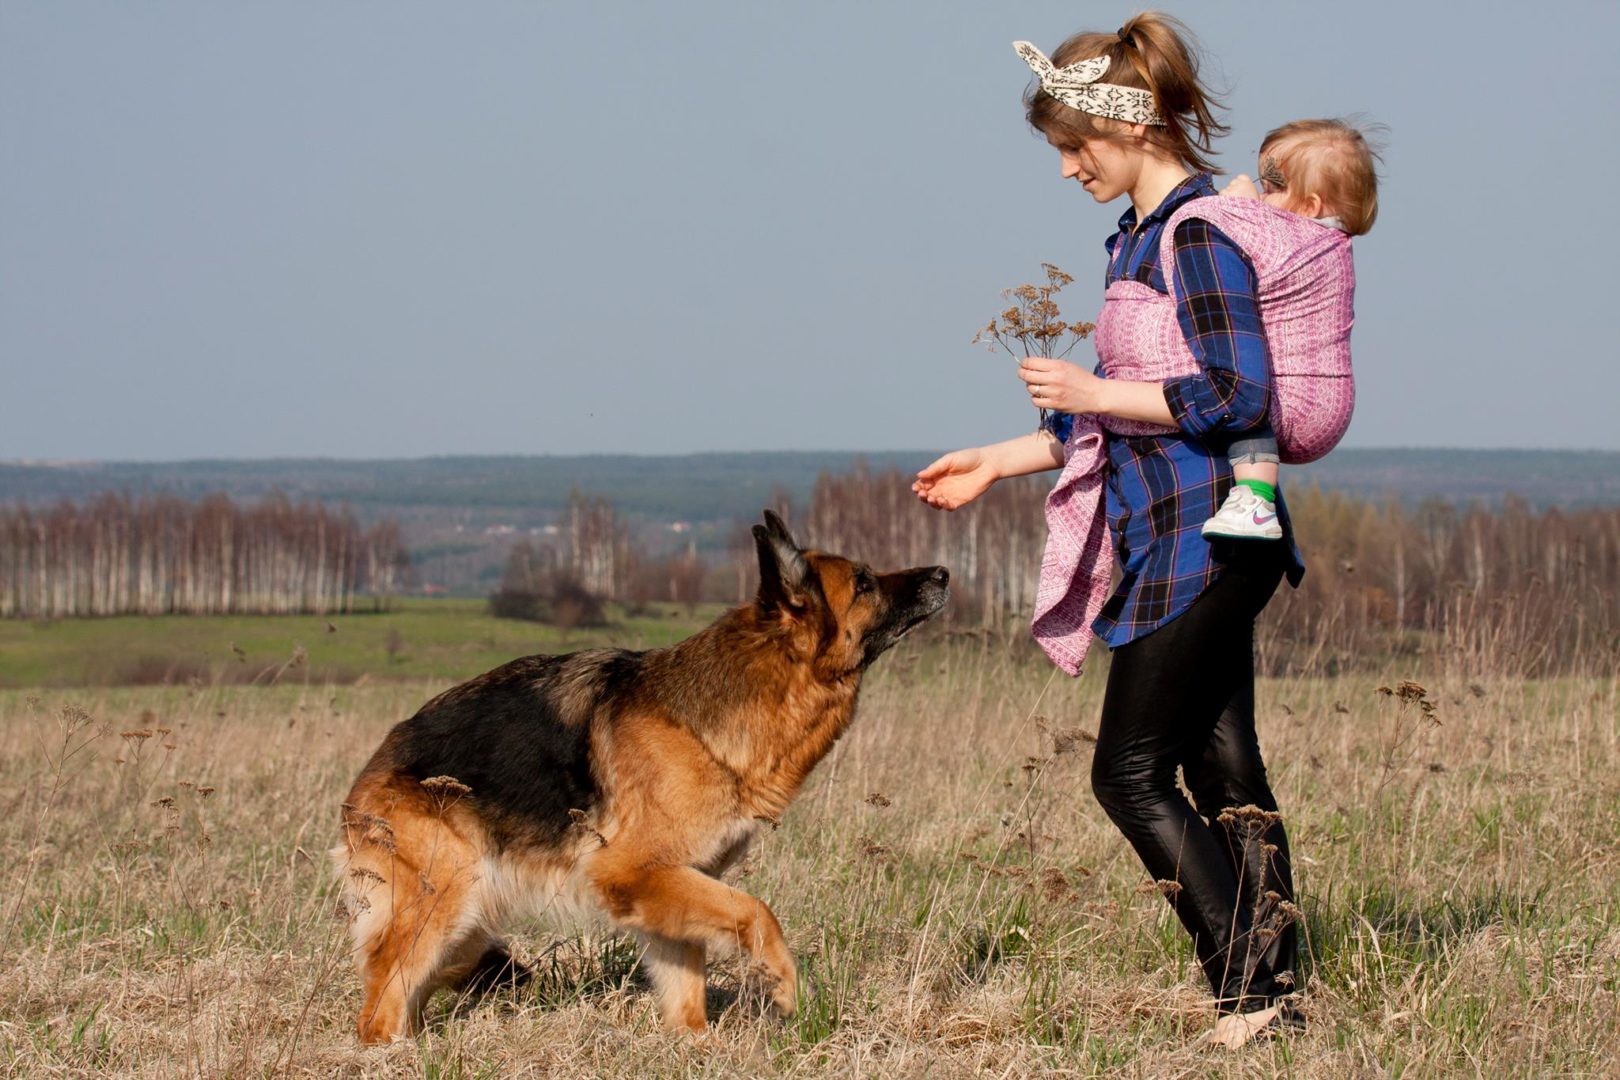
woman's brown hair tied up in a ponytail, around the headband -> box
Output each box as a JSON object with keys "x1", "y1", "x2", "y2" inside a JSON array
[{"x1": 1024, "y1": 11, "x2": 1226, "y2": 172}]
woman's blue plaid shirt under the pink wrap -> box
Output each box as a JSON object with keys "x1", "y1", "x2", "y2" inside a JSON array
[{"x1": 1048, "y1": 173, "x2": 1304, "y2": 648}]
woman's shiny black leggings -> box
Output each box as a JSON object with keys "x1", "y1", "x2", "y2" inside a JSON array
[{"x1": 1092, "y1": 541, "x2": 1296, "y2": 1012}]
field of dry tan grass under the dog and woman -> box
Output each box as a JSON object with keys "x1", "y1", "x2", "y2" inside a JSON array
[{"x1": 0, "y1": 636, "x2": 1620, "y2": 1077}]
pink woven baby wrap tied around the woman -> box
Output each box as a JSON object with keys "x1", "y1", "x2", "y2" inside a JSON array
[{"x1": 1032, "y1": 196, "x2": 1356, "y2": 675}]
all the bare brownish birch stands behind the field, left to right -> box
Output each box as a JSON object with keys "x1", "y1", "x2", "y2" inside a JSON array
[{"x1": 0, "y1": 465, "x2": 1620, "y2": 675}]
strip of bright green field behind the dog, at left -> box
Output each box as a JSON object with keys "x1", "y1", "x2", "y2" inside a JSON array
[{"x1": 0, "y1": 599, "x2": 719, "y2": 688}]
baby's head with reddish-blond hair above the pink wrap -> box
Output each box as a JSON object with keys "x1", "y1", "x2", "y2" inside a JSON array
[{"x1": 1260, "y1": 120, "x2": 1379, "y2": 236}]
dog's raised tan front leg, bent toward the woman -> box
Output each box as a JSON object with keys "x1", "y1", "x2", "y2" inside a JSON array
[{"x1": 590, "y1": 847, "x2": 799, "y2": 1027}]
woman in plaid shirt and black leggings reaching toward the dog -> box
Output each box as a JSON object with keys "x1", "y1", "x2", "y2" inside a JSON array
[{"x1": 914, "y1": 13, "x2": 1304, "y2": 1046}]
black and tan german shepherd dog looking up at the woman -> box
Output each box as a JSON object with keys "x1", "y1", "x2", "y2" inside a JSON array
[{"x1": 332, "y1": 512, "x2": 949, "y2": 1043}]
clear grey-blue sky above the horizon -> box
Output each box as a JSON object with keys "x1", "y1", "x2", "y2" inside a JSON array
[{"x1": 0, "y1": 0, "x2": 1620, "y2": 460}]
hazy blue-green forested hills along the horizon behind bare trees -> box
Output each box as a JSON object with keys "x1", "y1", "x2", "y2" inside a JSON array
[{"x1": 0, "y1": 449, "x2": 1620, "y2": 608}]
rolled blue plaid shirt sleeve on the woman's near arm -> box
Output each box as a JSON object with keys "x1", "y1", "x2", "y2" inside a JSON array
[{"x1": 1165, "y1": 219, "x2": 1272, "y2": 439}]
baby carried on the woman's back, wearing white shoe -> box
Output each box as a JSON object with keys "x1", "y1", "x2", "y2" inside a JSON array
[{"x1": 1202, "y1": 120, "x2": 1379, "y2": 539}]
